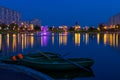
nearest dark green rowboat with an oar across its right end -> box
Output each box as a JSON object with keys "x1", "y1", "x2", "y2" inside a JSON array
[{"x1": 20, "y1": 58, "x2": 94, "y2": 70}]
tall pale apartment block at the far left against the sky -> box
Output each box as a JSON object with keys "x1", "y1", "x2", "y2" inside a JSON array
[{"x1": 0, "y1": 6, "x2": 21, "y2": 24}]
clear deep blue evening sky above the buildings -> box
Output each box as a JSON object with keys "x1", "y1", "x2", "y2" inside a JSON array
[{"x1": 0, "y1": 0, "x2": 120, "y2": 26}]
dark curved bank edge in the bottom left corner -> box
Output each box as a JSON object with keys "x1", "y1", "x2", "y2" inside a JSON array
[{"x1": 0, "y1": 63, "x2": 53, "y2": 80}]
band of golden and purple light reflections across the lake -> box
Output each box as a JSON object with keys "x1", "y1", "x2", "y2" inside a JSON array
[{"x1": 0, "y1": 33, "x2": 120, "y2": 54}]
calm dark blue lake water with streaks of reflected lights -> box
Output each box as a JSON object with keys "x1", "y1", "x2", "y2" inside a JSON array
[{"x1": 0, "y1": 33, "x2": 120, "y2": 80}]
